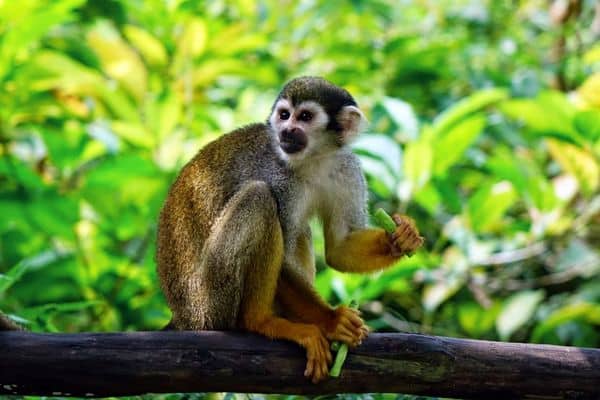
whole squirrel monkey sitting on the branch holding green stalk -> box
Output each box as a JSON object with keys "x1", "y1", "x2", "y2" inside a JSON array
[{"x1": 157, "y1": 77, "x2": 423, "y2": 382}]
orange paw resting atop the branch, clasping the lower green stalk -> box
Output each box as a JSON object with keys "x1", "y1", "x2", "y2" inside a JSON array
[{"x1": 325, "y1": 306, "x2": 369, "y2": 347}]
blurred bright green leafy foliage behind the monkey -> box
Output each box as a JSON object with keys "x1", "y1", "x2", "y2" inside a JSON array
[{"x1": 0, "y1": 0, "x2": 600, "y2": 398}]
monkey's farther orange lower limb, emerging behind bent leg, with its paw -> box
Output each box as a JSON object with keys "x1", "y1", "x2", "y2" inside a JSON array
[{"x1": 277, "y1": 265, "x2": 368, "y2": 347}]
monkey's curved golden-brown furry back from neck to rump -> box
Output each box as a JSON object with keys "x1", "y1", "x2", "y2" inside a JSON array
[{"x1": 156, "y1": 124, "x2": 285, "y2": 328}]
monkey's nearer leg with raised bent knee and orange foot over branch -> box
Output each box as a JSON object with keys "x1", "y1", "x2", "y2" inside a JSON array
[{"x1": 203, "y1": 181, "x2": 331, "y2": 382}]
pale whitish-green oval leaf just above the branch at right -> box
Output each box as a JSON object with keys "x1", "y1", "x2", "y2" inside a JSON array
[{"x1": 496, "y1": 290, "x2": 544, "y2": 340}]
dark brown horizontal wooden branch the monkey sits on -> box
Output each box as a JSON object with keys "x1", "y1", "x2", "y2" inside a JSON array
[{"x1": 0, "y1": 332, "x2": 600, "y2": 399}]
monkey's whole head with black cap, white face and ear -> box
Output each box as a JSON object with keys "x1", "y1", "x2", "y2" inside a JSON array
[{"x1": 268, "y1": 77, "x2": 365, "y2": 160}]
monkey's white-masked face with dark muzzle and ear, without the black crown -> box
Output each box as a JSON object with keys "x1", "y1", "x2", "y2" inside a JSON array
[{"x1": 269, "y1": 97, "x2": 364, "y2": 161}]
